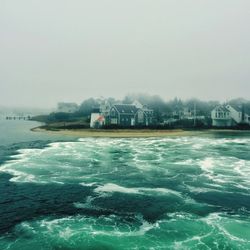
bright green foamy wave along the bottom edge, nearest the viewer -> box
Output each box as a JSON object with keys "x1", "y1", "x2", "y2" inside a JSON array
[{"x1": 0, "y1": 212, "x2": 250, "y2": 250}]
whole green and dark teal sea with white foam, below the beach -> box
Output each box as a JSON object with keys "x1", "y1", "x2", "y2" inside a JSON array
[{"x1": 0, "y1": 120, "x2": 250, "y2": 250}]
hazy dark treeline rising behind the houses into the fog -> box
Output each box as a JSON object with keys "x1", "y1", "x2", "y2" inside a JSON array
[{"x1": 32, "y1": 94, "x2": 250, "y2": 126}]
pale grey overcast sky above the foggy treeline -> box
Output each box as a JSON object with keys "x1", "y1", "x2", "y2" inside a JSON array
[{"x1": 0, "y1": 0, "x2": 250, "y2": 107}]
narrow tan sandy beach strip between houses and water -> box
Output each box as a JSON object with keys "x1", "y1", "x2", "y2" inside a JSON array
[{"x1": 31, "y1": 127, "x2": 250, "y2": 138}]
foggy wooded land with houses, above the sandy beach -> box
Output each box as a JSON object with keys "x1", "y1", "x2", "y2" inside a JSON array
[{"x1": 24, "y1": 94, "x2": 250, "y2": 131}]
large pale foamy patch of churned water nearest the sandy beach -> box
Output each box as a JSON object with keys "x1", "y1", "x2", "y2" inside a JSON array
[{"x1": 1, "y1": 137, "x2": 250, "y2": 195}]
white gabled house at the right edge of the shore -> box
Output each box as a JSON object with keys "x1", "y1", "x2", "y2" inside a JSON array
[{"x1": 211, "y1": 104, "x2": 250, "y2": 127}]
